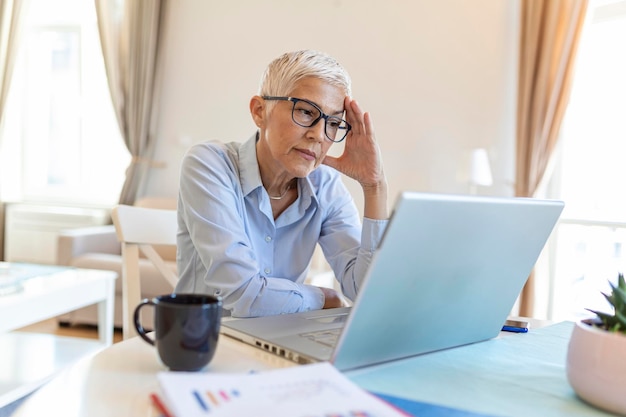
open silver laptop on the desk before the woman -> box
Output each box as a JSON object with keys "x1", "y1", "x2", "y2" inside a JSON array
[{"x1": 221, "y1": 192, "x2": 564, "y2": 371}]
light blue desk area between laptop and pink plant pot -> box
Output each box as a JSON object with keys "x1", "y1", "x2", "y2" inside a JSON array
[{"x1": 348, "y1": 322, "x2": 612, "y2": 417}]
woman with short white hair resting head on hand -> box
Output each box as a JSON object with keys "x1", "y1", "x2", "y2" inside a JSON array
[{"x1": 176, "y1": 50, "x2": 388, "y2": 317}]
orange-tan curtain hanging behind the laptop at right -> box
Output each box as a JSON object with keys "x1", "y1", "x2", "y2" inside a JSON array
[{"x1": 515, "y1": 0, "x2": 588, "y2": 316}]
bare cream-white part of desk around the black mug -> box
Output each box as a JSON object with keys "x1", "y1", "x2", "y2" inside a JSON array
[{"x1": 12, "y1": 335, "x2": 296, "y2": 417}]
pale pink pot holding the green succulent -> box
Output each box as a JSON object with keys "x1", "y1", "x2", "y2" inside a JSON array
[{"x1": 566, "y1": 320, "x2": 626, "y2": 416}]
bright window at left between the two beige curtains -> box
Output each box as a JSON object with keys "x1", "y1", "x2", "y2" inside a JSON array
[{"x1": 0, "y1": 0, "x2": 130, "y2": 205}]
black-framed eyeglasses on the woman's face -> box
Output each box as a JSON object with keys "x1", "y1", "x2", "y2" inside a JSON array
[{"x1": 263, "y1": 96, "x2": 352, "y2": 143}]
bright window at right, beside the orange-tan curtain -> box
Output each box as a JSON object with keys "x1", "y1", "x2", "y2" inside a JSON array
[{"x1": 549, "y1": 0, "x2": 626, "y2": 320}]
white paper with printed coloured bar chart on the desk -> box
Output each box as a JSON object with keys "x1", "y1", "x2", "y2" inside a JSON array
[{"x1": 158, "y1": 362, "x2": 407, "y2": 417}]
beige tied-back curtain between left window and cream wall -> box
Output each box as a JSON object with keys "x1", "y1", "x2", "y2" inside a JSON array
[{"x1": 95, "y1": 0, "x2": 166, "y2": 204}]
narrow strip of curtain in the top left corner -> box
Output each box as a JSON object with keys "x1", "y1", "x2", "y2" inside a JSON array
[{"x1": 0, "y1": 0, "x2": 28, "y2": 132}]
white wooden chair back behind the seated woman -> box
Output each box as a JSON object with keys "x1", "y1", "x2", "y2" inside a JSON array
[{"x1": 111, "y1": 204, "x2": 178, "y2": 339}]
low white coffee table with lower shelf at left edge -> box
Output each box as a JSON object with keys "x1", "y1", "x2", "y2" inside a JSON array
[{"x1": 0, "y1": 262, "x2": 117, "y2": 407}]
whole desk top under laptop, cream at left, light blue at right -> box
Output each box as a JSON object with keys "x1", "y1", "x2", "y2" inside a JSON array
[{"x1": 15, "y1": 323, "x2": 607, "y2": 417}]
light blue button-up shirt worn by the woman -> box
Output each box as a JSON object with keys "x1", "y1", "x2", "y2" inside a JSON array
[{"x1": 176, "y1": 135, "x2": 388, "y2": 317}]
